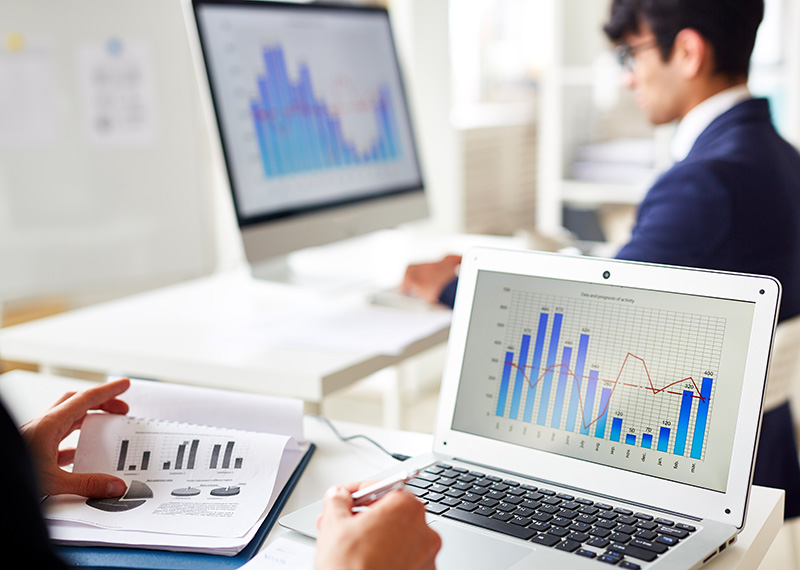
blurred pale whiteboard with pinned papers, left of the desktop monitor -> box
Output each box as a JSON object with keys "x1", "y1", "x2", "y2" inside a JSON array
[{"x1": 0, "y1": 0, "x2": 215, "y2": 301}]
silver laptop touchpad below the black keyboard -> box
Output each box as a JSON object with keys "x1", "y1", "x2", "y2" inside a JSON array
[{"x1": 430, "y1": 520, "x2": 533, "y2": 570}]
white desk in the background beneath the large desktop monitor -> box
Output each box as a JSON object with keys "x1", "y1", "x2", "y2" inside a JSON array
[{"x1": 0, "y1": 231, "x2": 522, "y2": 409}]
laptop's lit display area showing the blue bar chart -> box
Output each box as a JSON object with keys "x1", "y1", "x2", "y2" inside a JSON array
[{"x1": 452, "y1": 270, "x2": 755, "y2": 492}]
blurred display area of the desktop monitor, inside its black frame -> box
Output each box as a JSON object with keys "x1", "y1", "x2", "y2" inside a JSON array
[{"x1": 200, "y1": 6, "x2": 420, "y2": 216}]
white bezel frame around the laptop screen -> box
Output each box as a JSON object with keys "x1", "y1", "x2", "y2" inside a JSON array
[{"x1": 433, "y1": 248, "x2": 780, "y2": 529}]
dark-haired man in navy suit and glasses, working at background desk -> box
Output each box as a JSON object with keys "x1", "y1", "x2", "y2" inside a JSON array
[{"x1": 403, "y1": 0, "x2": 800, "y2": 517}]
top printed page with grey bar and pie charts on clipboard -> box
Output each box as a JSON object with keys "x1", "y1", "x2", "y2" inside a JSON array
[{"x1": 48, "y1": 414, "x2": 289, "y2": 537}]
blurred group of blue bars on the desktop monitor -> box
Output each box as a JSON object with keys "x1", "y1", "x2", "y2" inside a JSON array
[{"x1": 250, "y1": 47, "x2": 402, "y2": 177}]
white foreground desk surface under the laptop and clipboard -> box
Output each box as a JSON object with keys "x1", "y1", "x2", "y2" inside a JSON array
[{"x1": 0, "y1": 371, "x2": 784, "y2": 570}]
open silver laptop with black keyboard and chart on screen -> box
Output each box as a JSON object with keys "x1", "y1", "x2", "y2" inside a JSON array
[{"x1": 280, "y1": 248, "x2": 781, "y2": 570}]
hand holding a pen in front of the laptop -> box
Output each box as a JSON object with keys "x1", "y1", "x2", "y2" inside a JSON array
[{"x1": 314, "y1": 483, "x2": 442, "y2": 570}]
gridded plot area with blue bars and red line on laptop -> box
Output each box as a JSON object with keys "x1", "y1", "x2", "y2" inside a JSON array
[{"x1": 493, "y1": 291, "x2": 726, "y2": 460}]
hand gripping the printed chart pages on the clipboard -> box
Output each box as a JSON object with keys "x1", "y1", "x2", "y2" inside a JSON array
[{"x1": 20, "y1": 378, "x2": 130, "y2": 498}]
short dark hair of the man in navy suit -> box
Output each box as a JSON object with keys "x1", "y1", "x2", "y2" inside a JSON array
[{"x1": 603, "y1": 0, "x2": 764, "y2": 76}]
